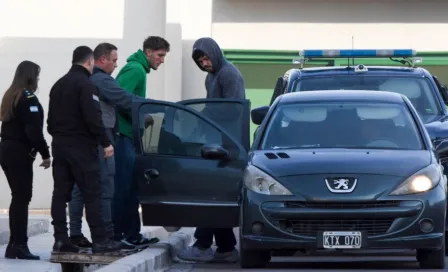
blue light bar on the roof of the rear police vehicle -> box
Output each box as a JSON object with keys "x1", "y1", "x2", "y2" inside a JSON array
[{"x1": 297, "y1": 65, "x2": 431, "y2": 78}]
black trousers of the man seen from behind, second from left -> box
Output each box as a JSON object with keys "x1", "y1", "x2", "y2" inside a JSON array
[{"x1": 51, "y1": 145, "x2": 107, "y2": 243}]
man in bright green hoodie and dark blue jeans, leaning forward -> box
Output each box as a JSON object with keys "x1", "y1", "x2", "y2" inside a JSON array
[{"x1": 113, "y1": 36, "x2": 170, "y2": 245}]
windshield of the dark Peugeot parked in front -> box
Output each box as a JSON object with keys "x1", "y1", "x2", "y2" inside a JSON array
[{"x1": 261, "y1": 102, "x2": 423, "y2": 150}]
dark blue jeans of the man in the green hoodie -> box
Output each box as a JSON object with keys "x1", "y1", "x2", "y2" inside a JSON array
[{"x1": 112, "y1": 135, "x2": 141, "y2": 241}]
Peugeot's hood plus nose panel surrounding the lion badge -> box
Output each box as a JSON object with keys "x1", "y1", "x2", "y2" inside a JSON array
[{"x1": 251, "y1": 149, "x2": 432, "y2": 201}]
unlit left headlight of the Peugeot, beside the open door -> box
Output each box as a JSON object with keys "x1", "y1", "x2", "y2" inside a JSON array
[{"x1": 243, "y1": 165, "x2": 292, "y2": 195}]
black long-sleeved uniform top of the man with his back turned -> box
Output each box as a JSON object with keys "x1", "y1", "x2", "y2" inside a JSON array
[{"x1": 47, "y1": 65, "x2": 111, "y2": 147}]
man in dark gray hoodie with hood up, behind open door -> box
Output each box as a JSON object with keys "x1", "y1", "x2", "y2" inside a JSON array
[{"x1": 178, "y1": 38, "x2": 246, "y2": 262}]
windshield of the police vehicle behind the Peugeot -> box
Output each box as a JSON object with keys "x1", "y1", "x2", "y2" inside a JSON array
[{"x1": 294, "y1": 75, "x2": 442, "y2": 123}]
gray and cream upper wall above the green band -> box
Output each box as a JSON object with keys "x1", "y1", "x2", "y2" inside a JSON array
[{"x1": 212, "y1": 0, "x2": 448, "y2": 51}]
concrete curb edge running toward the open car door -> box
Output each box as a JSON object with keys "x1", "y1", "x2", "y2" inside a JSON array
[{"x1": 96, "y1": 228, "x2": 195, "y2": 272}]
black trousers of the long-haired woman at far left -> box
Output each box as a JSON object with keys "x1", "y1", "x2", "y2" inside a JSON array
[{"x1": 0, "y1": 140, "x2": 34, "y2": 245}]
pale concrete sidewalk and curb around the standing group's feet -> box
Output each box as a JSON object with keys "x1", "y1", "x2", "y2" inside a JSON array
[{"x1": 0, "y1": 213, "x2": 193, "y2": 272}]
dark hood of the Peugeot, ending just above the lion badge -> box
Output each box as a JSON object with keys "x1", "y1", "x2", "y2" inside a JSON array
[{"x1": 250, "y1": 149, "x2": 431, "y2": 178}]
